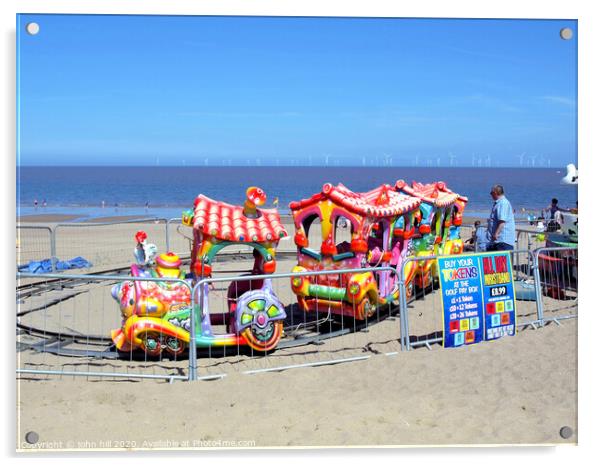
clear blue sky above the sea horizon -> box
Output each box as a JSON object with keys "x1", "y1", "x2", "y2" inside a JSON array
[{"x1": 17, "y1": 15, "x2": 577, "y2": 167}]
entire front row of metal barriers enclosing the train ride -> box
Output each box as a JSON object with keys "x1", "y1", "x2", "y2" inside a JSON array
[{"x1": 17, "y1": 248, "x2": 577, "y2": 381}]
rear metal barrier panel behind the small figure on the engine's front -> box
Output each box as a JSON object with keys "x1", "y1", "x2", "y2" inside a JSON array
[{"x1": 54, "y1": 218, "x2": 167, "y2": 273}]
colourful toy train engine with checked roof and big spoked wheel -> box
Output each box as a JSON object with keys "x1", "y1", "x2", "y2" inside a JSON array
[{"x1": 112, "y1": 187, "x2": 286, "y2": 356}]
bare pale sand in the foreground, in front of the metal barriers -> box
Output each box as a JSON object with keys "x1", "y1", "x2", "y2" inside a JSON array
[{"x1": 19, "y1": 321, "x2": 577, "y2": 448}]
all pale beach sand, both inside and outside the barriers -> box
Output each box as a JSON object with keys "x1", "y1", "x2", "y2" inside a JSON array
[{"x1": 17, "y1": 217, "x2": 577, "y2": 449}]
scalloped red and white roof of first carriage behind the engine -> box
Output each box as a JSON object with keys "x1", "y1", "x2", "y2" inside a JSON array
[{"x1": 289, "y1": 183, "x2": 420, "y2": 217}]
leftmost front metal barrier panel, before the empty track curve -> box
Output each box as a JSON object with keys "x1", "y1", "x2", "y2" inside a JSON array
[{"x1": 17, "y1": 274, "x2": 191, "y2": 381}]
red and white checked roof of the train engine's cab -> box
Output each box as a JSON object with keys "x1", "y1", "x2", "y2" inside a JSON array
[{"x1": 193, "y1": 194, "x2": 287, "y2": 243}]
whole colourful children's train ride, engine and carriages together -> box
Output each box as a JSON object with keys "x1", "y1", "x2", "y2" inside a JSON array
[{"x1": 111, "y1": 180, "x2": 468, "y2": 357}]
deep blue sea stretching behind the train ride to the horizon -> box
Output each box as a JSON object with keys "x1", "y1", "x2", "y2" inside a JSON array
[{"x1": 17, "y1": 166, "x2": 577, "y2": 221}]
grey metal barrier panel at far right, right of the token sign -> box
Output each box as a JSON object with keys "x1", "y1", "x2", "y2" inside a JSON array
[{"x1": 534, "y1": 247, "x2": 578, "y2": 325}]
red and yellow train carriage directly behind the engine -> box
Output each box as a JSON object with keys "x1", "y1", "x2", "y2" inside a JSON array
[{"x1": 290, "y1": 183, "x2": 420, "y2": 319}]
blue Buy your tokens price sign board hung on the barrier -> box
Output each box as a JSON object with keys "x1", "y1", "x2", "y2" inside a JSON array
[{"x1": 437, "y1": 252, "x2": 516, "y2": 347}]
